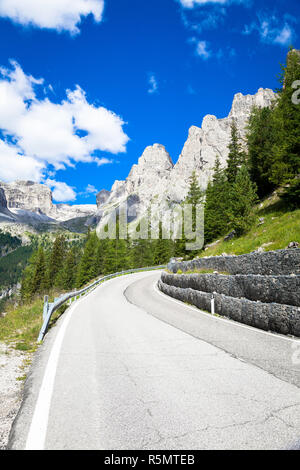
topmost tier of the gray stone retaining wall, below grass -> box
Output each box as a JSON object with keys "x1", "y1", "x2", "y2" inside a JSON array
[{"x1": 168, "y1": 248, "x2": 300, "y2": 276}]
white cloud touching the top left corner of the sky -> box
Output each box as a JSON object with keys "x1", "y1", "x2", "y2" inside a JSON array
[{"x1": 0, "y1": 0, "x2": 104, "y2": 34}]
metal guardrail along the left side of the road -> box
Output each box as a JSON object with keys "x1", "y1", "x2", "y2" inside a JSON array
[{"x1": 38, "y1": 265, "x2": 167, "y2": 342}]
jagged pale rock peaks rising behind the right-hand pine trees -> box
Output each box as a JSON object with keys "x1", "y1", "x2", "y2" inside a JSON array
[{"x1": 100, "y1": 88, "x2": 276, "y2": 233}]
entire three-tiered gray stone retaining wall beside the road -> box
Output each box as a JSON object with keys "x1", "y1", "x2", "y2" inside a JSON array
[{"x1": 159, "y1": 249, "x2": 300, "y2": 337}]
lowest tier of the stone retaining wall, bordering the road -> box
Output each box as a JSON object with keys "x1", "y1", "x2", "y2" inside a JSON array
[{"x1": 158, "y1": 280, "x2": 300, "y2": 337}]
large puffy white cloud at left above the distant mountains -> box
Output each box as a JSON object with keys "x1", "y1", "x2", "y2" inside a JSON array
[{"x1": 0, "y1": 62, "x2": 129, "y2": 185}]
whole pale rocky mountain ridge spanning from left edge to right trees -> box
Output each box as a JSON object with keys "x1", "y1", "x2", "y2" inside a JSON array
[{"x1": 0, "y1": 88, "x2": 276, "y2": 235}]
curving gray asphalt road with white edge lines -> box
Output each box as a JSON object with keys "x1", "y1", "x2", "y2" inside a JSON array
[{"x1": 9, "y1": 272, "x2": 300, "y2": 450}]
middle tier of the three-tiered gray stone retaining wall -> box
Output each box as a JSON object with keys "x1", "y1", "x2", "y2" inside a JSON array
[{"x1": 161, "y1": 273, "x2": 300, "y2": 307}]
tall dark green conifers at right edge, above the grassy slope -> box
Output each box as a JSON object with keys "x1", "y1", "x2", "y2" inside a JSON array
[{"x1": 247, "y1": 49, "x2": 300, "y2": 203}]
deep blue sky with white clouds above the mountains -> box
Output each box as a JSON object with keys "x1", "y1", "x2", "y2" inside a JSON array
[{"x1": 0, "y1": 0, "x2": 300, "y2": 204}]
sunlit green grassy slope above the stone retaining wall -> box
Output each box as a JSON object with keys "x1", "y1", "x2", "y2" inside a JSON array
[{"x1": 200, "y1": 195, "x2": 300, "y2": 257}]
